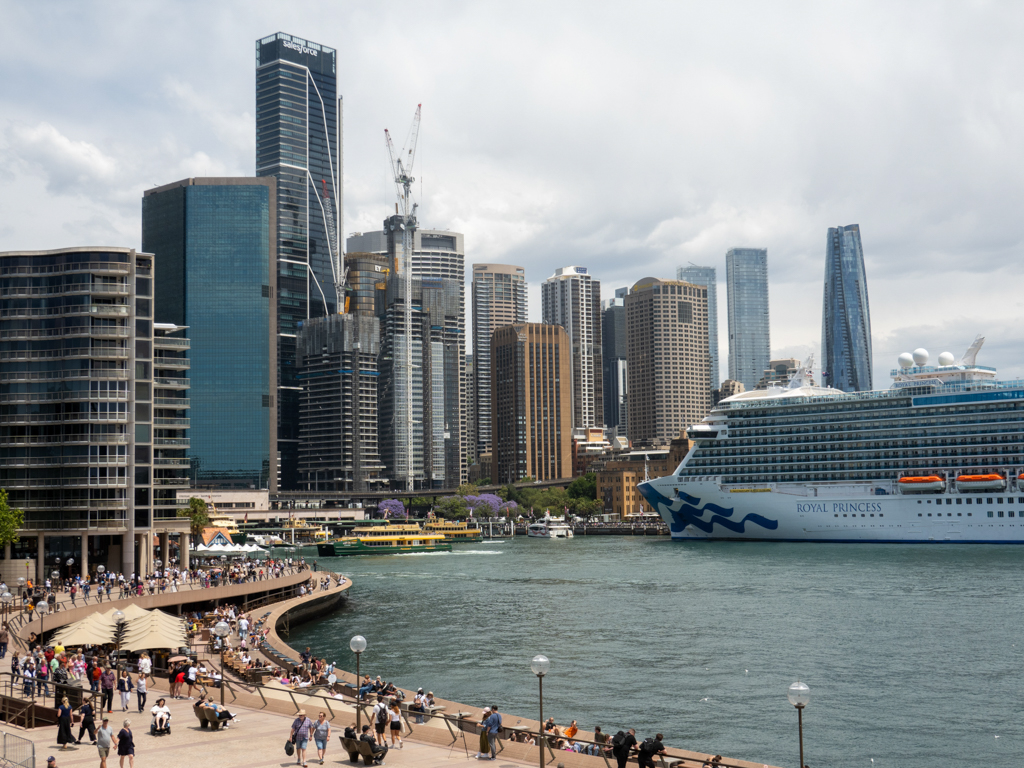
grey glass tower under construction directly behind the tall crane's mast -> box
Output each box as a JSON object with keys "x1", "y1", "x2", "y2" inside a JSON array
[{"x1": 378, "y1": 273, "x2": 465, "y2": 488}]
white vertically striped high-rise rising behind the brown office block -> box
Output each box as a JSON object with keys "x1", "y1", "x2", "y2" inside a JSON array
[{"x1": 541, "y1": 266, "x2": 604, "y2": 428}]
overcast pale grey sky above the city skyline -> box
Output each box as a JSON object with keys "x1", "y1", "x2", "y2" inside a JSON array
[{"x1": 0, "y1": 0, "x2": 1024, "y2": 387}]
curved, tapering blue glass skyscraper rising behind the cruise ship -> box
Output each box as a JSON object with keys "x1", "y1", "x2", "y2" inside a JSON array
[{"x1": 821, "y1": 224, "x2": 871, "y2": 392}]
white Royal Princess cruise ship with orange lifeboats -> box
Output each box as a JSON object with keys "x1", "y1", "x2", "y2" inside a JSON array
[{"x1": 639, "y1": 336, "x2": 1024, "y2": 544}]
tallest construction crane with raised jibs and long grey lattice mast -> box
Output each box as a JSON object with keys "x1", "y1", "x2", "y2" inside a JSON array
[{"x1": 384, "y1": 104, "x2": 423, "y2": 490}]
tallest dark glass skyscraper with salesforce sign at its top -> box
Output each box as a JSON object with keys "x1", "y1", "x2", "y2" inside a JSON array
[{"x1": 256, "y1": 32, "x2": 343, "y2": 490}]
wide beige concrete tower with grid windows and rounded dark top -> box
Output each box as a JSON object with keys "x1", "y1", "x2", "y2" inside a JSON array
[{"x1": 626, "y1": 278, "x2": 711, "y2": 445}]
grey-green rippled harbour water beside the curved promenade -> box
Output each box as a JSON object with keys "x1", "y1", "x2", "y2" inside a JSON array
[{"x1": 291, "y1": 537, "x2": 1024, "y2": 768}]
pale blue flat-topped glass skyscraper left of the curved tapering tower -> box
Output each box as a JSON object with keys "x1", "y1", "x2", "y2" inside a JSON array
[{"x1": 725, "y1": 248, "x2": 771, "y2": 389}]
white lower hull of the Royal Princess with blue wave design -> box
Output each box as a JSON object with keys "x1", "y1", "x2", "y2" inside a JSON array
[{"x1": 638, "y1": 475, "x2": 1024, "y2": 544}]
